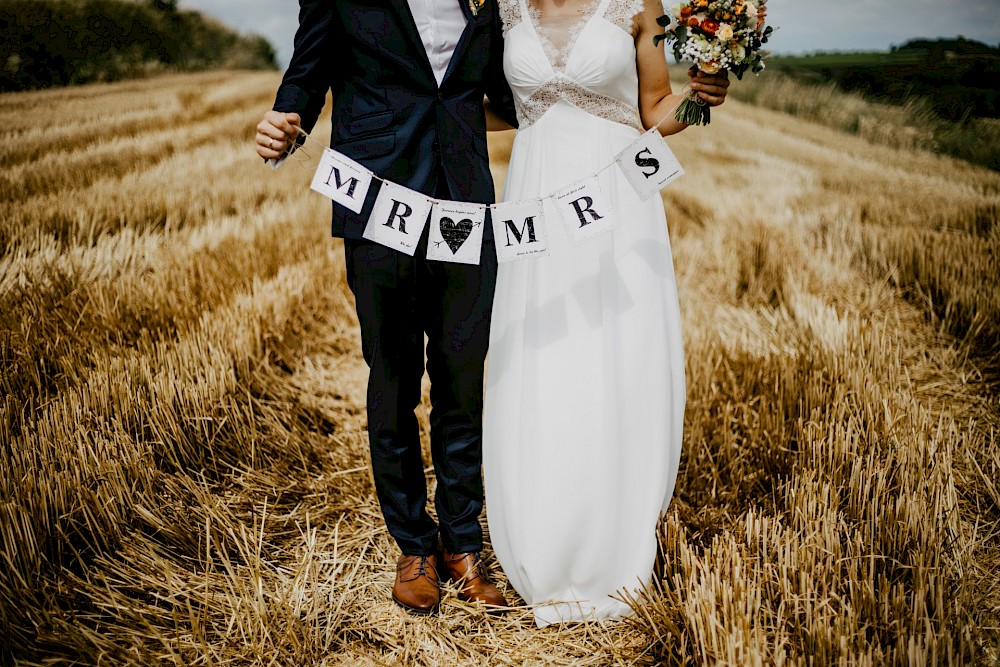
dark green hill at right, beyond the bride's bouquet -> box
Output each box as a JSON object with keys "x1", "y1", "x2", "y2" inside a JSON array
[{"x1": 768, "y1": 37, "x2": 1000, "y2": 121}]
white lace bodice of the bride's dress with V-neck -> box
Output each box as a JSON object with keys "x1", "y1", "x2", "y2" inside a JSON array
[{"x1": 497, "y1": 0, "x2": 644, "y2": 131}]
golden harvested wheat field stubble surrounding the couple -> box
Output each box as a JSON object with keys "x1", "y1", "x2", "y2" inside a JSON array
[{"x1": 0, "y1": 72, "x2": 1000, "y2": 667}]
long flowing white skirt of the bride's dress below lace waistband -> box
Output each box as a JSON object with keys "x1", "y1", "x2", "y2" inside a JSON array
[{"x1": 483, "y1": 102, "x2": 685, "y2": 626}]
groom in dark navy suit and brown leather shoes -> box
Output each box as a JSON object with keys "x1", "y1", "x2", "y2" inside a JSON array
[{"x1": 257, "y1": 0, "x2": 516, "y2": 613}]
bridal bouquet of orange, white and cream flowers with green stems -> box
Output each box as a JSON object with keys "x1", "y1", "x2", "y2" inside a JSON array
[{"x1": 654, "y1": 0, "x2": 773, "y2": 125}]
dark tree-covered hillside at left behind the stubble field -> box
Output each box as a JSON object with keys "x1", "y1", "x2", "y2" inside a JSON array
[{"x1": 0, "y1": 0, "x2": 277, "y2": 91}]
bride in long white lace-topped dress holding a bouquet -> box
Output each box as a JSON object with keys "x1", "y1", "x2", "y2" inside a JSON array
[{"x1": 483, "y1": 0, "x2": 728, "y2": 626}]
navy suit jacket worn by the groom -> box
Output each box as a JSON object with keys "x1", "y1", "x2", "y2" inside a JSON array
[{"x1": 274, "y1": 0, "x2": 517, "y2": 239}]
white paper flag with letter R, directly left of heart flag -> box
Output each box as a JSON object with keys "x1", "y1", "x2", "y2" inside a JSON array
[{"x1": 362, "y1": 181, "x2": 433, "y2": 257}]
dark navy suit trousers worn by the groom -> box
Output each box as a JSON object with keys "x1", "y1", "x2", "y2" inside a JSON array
[{"x1": 344, "y1": 180, "x2": 497, "y2": 555}]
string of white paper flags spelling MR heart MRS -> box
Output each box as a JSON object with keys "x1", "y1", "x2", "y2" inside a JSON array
[{"x1": 312, "y1": 128, "x2": 684, "y2": 264}]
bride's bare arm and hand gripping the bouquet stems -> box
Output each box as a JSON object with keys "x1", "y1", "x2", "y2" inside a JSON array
[{"x1": 635, "y1": 0, "x2": 729, "y2": 136}]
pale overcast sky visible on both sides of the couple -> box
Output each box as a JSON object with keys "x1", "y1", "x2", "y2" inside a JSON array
[{"x1": 180, "y1": 0, "x2": 1000, "y2": 67}]
